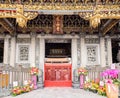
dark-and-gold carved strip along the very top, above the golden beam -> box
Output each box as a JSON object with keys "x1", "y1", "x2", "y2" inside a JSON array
[{"x1": 0, "y1": 0, "x2": 119, "y2": 4}]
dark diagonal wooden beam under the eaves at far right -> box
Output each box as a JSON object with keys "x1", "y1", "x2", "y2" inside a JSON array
[{"x1": 101, "y1": 19, "x2": 119, "y2": 35}]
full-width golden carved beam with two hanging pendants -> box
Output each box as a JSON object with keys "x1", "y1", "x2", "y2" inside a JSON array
[{"x1": 0, "y1": 3, "x2": 120, "y2": 28}]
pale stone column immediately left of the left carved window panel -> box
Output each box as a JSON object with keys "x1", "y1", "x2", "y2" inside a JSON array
[{"x1": 10, "y1": 37, "x2": 16, "y2": 67}]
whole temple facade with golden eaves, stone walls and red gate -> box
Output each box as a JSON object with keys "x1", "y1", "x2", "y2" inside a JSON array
[{"x1": 0, "y1": 0, "x2": 120, "y2": 86}]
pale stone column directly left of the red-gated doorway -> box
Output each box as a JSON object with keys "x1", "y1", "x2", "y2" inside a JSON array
[{"x1": 39, "y1": 38, "x2": 45, "y2": 73}]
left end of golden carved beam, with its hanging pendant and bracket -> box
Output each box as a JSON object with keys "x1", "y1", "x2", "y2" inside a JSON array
[{"x1": 0, "y1": 4, "x2": 38, "y2": 27}]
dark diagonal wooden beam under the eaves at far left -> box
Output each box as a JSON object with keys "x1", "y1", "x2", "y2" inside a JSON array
[{"x1": 0, "y1": 19, "x2": 15, "y2": 34}]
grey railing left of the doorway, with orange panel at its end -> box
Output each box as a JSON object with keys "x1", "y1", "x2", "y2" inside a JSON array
[{"x1": 0, "y1": 65, "x2": 31, "y2": 97}]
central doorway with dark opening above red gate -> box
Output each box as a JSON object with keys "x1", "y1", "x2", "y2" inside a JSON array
[{"x1": 44, "y1": 40, "x2": 72, "y2": 87}]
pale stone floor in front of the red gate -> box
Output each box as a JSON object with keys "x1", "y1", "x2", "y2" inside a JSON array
[{"x1": 3, "y1": 87, "x2": 107, "y2": 98}]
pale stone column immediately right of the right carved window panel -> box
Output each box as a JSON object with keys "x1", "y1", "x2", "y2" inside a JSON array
[{"x1": 100, "y1": 37, "x2": 106, "y2": 67}]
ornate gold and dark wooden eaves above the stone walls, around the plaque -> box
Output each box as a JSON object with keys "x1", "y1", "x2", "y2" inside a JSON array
[{"x1": 0, "y1": 0, "x2": 120, "y2": 35}]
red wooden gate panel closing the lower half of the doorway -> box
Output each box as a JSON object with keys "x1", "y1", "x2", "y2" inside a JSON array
[{"x1": 44, "y1": 63, "x2": 72, "y2": 87}]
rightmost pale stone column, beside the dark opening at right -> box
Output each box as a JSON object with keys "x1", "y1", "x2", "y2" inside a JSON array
[{"x1": 107, "y1": 38, "x2": 112, "y2": 66}]
